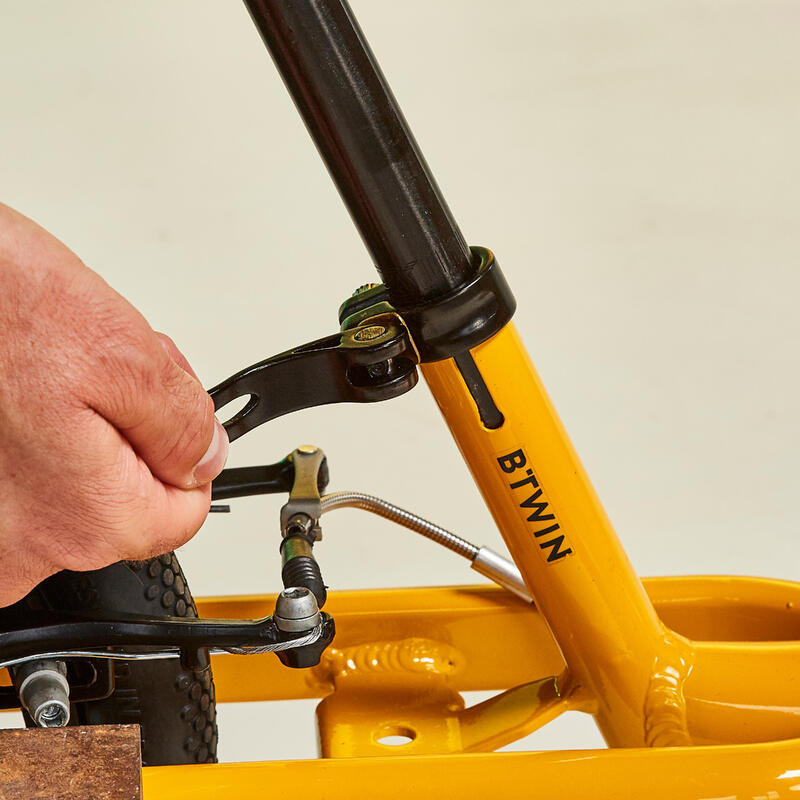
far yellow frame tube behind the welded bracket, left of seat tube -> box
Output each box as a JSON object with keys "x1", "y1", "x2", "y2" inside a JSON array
[{"x1": 198, "y1": 586, "x2": 564, "y2": 702}]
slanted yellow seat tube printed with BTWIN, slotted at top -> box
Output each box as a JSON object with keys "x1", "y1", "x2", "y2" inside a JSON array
[{"x1": 422, "y1": 324, "x2": 691, "y2": 747}]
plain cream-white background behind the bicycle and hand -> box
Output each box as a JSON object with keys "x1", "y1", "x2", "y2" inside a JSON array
[{"x1": 0, "y1": 0, "x2": 800, "y2": 760}]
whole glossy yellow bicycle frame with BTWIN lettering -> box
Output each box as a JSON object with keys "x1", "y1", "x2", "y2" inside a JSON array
[{"x1": 139, "y1": 308, "x2": 800, "y2": 800}]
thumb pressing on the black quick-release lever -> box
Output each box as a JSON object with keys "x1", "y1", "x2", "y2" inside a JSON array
[{"x1": 85, "y1": 332, "x2": 228, "y2": 489}]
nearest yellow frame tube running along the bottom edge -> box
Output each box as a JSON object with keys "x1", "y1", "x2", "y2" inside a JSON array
[{"x1": 144, "y1": 741, "x2": 800, "y2": 800}]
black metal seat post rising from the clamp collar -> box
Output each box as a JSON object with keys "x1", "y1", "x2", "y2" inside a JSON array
[{"x1": 245, "y1": 0, "x2": 477, "y2": 306}]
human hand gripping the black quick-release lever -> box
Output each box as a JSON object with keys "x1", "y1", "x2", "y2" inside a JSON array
[{"x1": 0, "y1": 204, "x2": 228, "y2": 606}]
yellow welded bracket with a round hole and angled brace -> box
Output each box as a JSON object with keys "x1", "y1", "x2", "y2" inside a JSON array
[{"x1": 317, "y1": 638, "x2": 585, "y2": 758}]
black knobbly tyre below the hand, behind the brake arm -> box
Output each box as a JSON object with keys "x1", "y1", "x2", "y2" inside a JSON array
[{"x1": 18, "y1": 553, "x2": 217, "y2": 766}]
